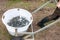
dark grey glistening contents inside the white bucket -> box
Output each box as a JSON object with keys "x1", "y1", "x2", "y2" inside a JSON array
[{"x1": 7, "y1": 16, "x2": 29, "y2": 27}]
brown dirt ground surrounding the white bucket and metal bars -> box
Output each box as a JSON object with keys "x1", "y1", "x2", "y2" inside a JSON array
[{"x1": 0, "y1": 1, "x2": 60, "y2": 40}]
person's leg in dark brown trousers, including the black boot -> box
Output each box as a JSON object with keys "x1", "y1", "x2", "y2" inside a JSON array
[{"x1": 37, "y1": 8, "x2": 59, "y2": 28}]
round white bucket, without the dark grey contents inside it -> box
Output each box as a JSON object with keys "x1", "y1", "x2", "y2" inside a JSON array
[{"x1": 2, "y1": 8, "x2": 33, "y2": 36}]
